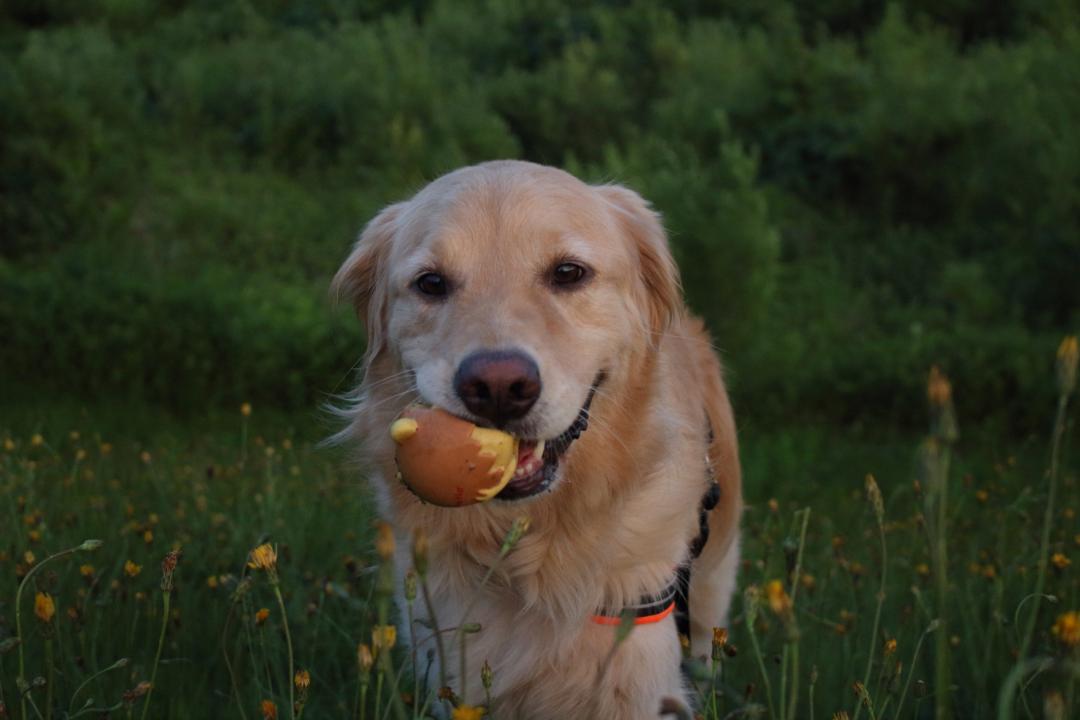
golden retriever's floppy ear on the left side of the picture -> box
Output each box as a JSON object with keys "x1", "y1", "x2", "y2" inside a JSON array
[{"x1": 330, "y1": 203, "x2": 405, "y2": 357}]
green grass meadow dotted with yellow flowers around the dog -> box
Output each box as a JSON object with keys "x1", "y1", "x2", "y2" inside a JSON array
[{"x1": 0, "y1": 345, "x2": 1080, "y2": 719}]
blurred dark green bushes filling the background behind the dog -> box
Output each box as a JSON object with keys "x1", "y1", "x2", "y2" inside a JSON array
[{"x1": 0, "y1": 0, "x2": 1080, "y2": 432}]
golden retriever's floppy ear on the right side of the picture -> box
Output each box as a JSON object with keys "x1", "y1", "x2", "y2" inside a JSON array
[{"x1": 596, "y1": 185, "x2": 681, "y2": 334}]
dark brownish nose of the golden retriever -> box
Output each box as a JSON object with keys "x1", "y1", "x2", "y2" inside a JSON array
[{"x1": 454, "y1": 350, "x2": 541, "y2": 427}]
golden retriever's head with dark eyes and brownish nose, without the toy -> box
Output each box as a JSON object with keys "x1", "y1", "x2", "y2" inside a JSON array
[{"x1": 334, "y1": 161, "x2": 680, "y2": 500}]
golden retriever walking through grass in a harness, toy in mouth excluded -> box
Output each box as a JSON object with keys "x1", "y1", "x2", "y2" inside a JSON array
[{"x1": 334, "y1": 161, "x2": 742, "y2": 720}]
